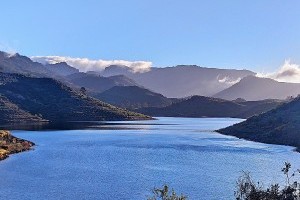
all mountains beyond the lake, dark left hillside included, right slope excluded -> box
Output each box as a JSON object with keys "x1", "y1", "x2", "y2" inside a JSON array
[{"x1": 0, "y1": 49, "x2": 300, "y2": 124}]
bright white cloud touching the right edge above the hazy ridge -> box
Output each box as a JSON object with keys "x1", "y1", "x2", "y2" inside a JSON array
[{"x1": 257, "y1": 60, "x2": 300, "y2": 83}]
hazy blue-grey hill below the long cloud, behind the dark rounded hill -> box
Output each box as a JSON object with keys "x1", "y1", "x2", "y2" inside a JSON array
[{"x1": 66, "y1": 72, "x2": 136, "y2": 93}]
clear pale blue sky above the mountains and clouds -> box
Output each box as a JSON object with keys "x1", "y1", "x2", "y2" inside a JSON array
[{"x1": 0, "y1": 0, "x2": 300, "y2": 72}]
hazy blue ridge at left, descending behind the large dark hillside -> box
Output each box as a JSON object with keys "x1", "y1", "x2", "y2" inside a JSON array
[{"x1": 0, "y1": 51, "x2": 141, "y2": 93}]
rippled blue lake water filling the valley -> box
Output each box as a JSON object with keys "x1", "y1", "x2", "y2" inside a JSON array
[{"x1": 0, "y1": 118, "x2": 300, "y2": 200}]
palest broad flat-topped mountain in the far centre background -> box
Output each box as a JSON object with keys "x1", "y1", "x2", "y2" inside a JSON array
[{"x1": 102, "y1": 65, "x2": 255, "y2": 98}]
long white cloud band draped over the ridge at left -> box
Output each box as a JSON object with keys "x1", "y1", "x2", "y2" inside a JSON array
[{"x1": 31, "y1": 56, "x2": 152, "y2": 72}]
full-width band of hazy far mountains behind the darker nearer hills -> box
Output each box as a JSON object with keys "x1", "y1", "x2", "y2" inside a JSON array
[{"x1": 0, "y1": 52, "x2": 300, "y2": 101}]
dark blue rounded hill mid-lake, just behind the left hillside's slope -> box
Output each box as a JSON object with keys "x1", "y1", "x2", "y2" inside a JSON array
[{"x1": 95, "y1": 86, "x2": 173, "y2": 110}]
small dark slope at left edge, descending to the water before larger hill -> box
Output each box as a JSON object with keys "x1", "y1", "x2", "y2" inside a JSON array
[{"x1": 0, "y1": 95, "x2": 46, "y2": 125}]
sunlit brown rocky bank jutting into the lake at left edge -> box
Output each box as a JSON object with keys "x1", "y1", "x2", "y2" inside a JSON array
[{"x1": 0, "y1": 130, "x2": 35, "y2": 161}]
